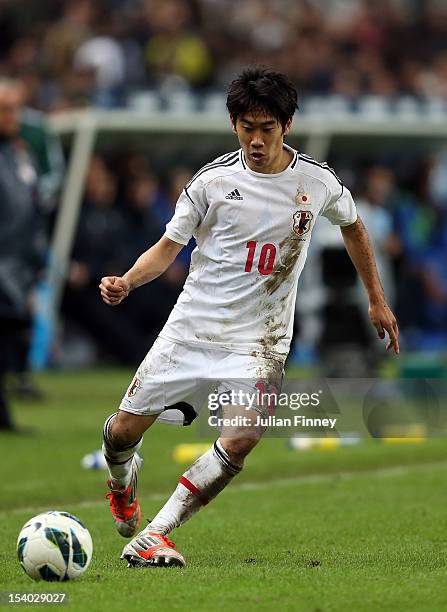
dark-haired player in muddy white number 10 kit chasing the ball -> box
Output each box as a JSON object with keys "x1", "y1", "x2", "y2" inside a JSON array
[{"x1": 100, "y1": 67, "x2": 399, "y2": 567}]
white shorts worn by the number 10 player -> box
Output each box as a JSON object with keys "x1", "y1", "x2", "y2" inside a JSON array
[{"x1": 119, "y1": 337, "x2": 284, "y2": 425}]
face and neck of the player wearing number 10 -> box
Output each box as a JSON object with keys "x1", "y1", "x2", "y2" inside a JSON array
[{"x1": 233, "y1": 112, "x2": 292, "y2": 174}]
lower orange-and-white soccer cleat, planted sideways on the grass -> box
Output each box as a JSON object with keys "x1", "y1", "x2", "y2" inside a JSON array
[{"x1": 121, "y1": 531, "x2": 186, "y2": 567}]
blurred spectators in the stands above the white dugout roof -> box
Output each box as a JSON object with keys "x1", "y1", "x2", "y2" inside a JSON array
[{"x1": 0, "y1": 0, "x2": 447, "y2": 111}]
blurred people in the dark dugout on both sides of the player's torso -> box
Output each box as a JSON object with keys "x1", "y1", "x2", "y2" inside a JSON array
[{"x1": 57, "y1": 144, "x2": 447, "y2": 364}]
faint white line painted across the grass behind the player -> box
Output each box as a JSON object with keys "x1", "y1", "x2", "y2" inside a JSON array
[{"x1": 0, "y1": 461, "x2": 447, "y2": 520}]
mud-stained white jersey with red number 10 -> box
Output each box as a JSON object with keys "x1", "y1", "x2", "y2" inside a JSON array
[{"x1": 160, "y1": 145, "x2": 357, "y2": 361}]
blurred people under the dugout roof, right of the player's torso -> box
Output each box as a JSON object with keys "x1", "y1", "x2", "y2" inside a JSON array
[{"x1": 295, "y1": 152, "x2": 447, "y2": 376}]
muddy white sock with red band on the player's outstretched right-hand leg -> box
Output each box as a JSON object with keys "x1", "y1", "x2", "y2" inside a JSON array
[{"x1": 146, "y1": 440, "x2": 242, "y2": 535}]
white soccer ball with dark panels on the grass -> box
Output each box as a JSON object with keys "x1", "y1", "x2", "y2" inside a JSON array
[{"x1": 17, "y1": 510, "x2": 93, "y2": 582}]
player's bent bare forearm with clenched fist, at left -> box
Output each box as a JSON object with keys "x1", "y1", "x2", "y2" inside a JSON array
[{"x1": 99, "y1": 236, "x2": 184, "y2": 306}]
